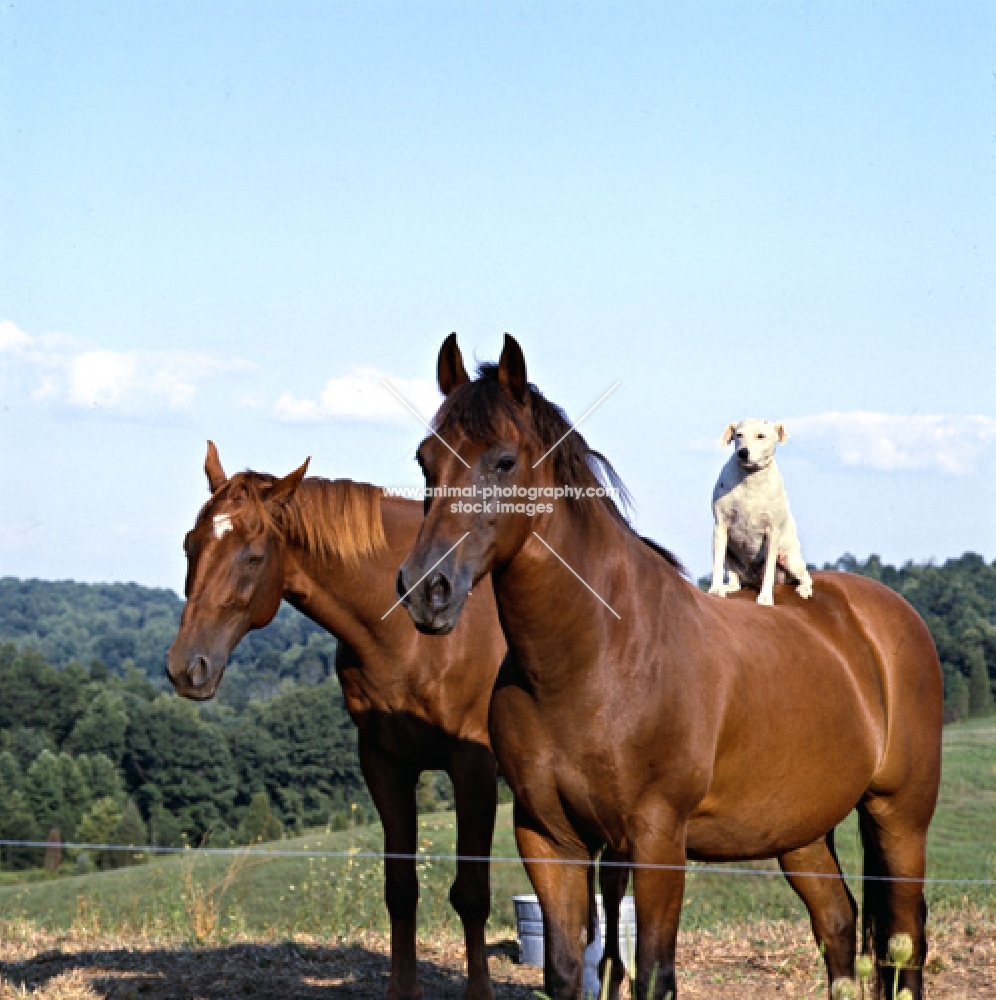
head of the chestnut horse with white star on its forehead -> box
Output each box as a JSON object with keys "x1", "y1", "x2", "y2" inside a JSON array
[{"x1": 166, "y1": 441, "x2": 308, "y2": 701}]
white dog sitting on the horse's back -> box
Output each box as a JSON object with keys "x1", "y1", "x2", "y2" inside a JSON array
[{"x1": 709, "y1": 420, "x2": 813, "y2": 605}]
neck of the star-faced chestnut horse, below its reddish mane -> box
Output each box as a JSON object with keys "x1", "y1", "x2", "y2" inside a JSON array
[{"x1": 284, "y1": 492, "x2": 422, "y2": 657}]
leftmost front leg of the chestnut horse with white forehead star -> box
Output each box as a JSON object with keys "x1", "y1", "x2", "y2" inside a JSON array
[{"x1": 359, "y1": 735, "x2": 422, "y2": 1000}]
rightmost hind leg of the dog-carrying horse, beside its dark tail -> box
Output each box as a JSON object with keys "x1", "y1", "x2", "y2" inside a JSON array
[{"x1": 858, "y1": 792, "x2": 930, "y2": 1000}]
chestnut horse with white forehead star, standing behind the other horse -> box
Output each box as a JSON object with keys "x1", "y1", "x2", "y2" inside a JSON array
[{"x1": 167, "y1": 442, "x2": 505, "y2": 1000}]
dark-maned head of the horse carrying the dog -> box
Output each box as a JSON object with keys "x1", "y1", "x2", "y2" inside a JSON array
[{"x1": 397, "y1": 334, "x2": 621, "y2": 635}]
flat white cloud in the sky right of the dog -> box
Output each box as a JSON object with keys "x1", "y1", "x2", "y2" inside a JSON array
[{"x1": 785, "y1": 411, "x2": 996, "y2": 475}]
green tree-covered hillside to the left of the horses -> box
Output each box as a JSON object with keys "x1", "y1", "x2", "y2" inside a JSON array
[{"x1": 0, "y1": 577, "x2": 362, "y2": 856}]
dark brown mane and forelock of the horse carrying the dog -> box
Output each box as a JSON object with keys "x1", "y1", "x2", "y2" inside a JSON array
[{"x1": 433, "y1": 361, "x2": 688, "y2": 576}]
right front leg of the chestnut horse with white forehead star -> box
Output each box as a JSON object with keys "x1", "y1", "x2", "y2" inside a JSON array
[{"x1": 449, "y1": 741, "x2": 498, "y2": 1000}]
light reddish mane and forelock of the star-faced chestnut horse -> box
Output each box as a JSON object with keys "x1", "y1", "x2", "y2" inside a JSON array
[{"x1": 212, "y1": 470, "x2": 387, "y2": 564}]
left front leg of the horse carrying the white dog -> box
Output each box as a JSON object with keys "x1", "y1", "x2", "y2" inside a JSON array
[{"x1": 515, "y1": 800, "x2": 590, "y2": 1000}]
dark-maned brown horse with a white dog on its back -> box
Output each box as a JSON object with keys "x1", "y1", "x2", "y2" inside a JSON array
[{"x1": 399, "y1": 336, "x2": 941, "y2": 1000}]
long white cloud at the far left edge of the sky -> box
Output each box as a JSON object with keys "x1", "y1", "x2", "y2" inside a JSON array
[{"x1": 0, "y1": 320, "x2": 255, "y2": 414}]
